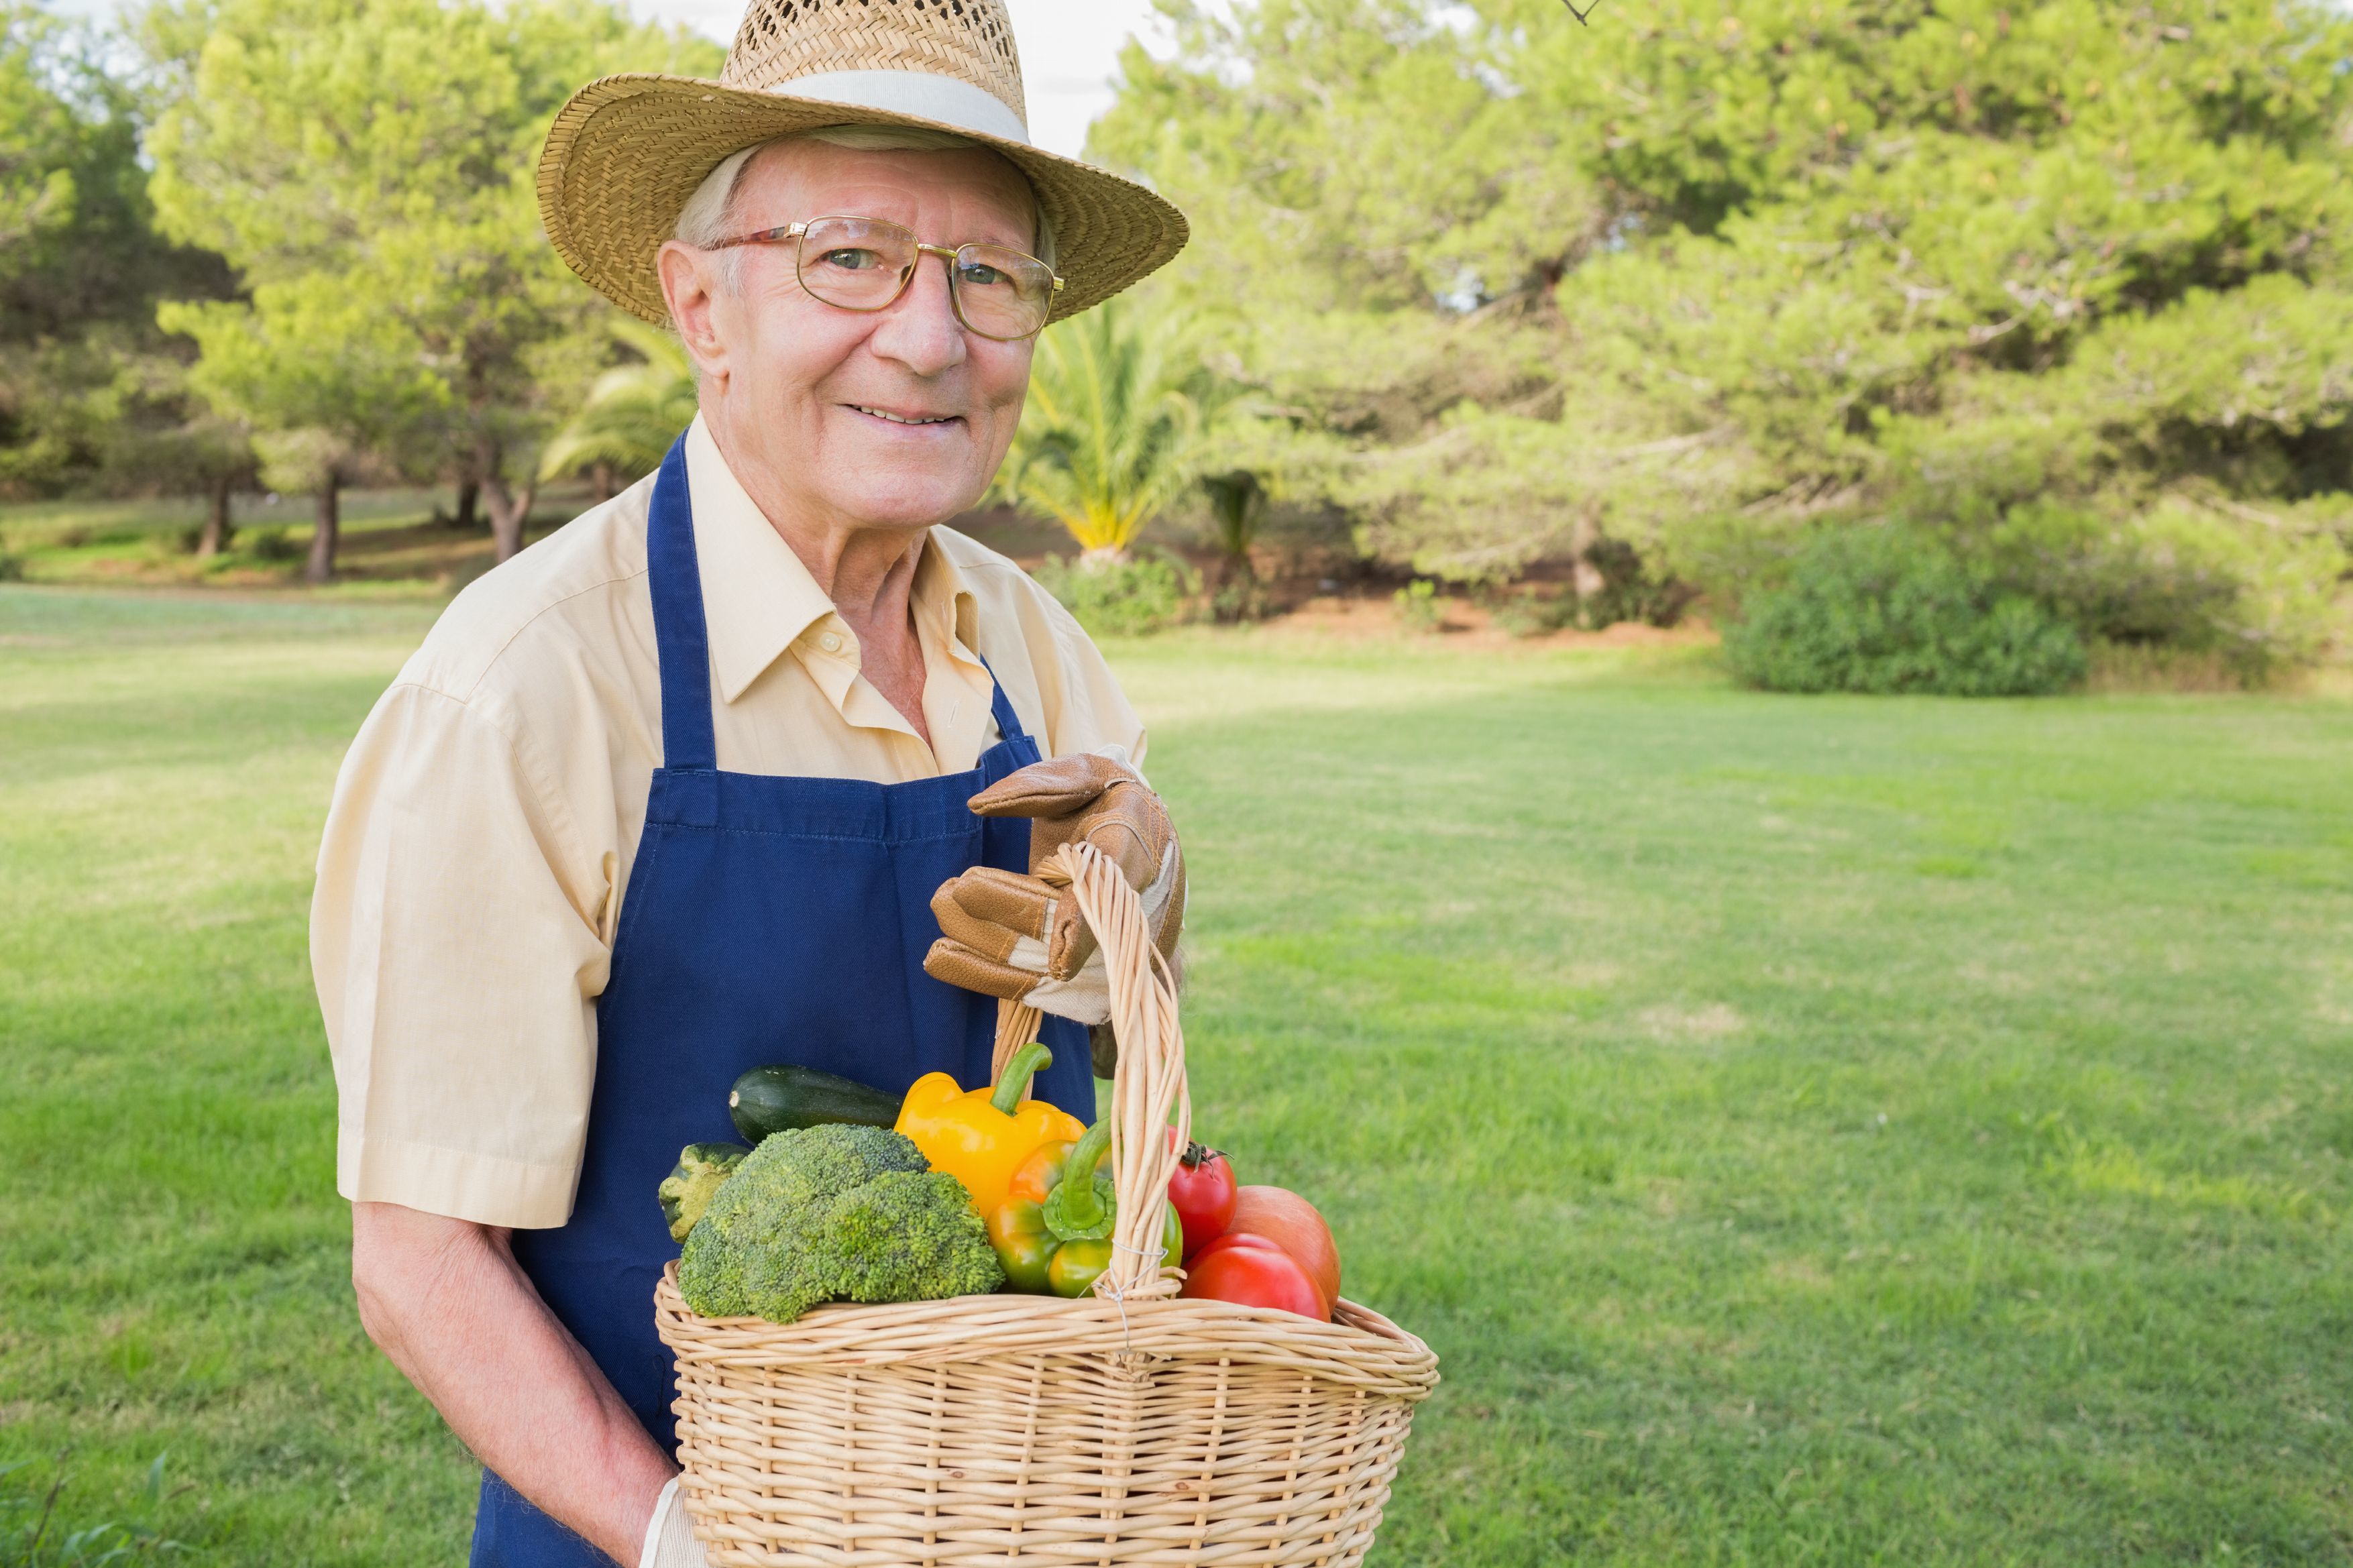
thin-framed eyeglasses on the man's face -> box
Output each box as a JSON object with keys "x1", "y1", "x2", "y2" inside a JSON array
[{"x1": 710, "y1": 217, "x2": 1061, "y2": 344}]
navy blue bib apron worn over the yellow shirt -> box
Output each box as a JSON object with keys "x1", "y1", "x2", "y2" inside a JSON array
[{"x1": 471, "y1": 440, "x2": 1094, "y2": 1568}]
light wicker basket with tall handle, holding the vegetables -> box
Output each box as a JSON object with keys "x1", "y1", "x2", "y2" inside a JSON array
[{"x1": 654, "y1": 848, "x2": 1437, "y2": 1568}]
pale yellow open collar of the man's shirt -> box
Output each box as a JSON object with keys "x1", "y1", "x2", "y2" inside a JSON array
[{"x1": 687, "y1": 414, "x2": 979, "y2": 706}]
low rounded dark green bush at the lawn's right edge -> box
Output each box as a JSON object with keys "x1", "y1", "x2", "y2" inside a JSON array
[{"x1": 1725, "y1": 527, "x2": 2087, "y2": 697}]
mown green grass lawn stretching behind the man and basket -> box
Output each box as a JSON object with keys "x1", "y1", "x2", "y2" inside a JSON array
[{"x1": 0, "y1": 589, "x2": 2353, "y2": 1568}]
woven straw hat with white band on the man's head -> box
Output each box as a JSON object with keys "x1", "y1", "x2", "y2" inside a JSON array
[{"x1": 539, "y1": 0, "x2": 1186, "y2": 323}]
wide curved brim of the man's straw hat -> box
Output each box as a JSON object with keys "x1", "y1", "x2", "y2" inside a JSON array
[{"x1": 539, "y1": 73, "x2": 1189, "y2": 325}]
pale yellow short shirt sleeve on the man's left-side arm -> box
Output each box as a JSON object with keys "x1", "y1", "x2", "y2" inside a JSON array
[{"x1": 311, "y1": 683, "x2": 614, "y2": 1229}]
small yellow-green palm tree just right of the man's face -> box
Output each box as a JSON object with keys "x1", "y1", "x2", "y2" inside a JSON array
[{"x1": 997, "y1": 299, "x2": 1219, "y2": 561}]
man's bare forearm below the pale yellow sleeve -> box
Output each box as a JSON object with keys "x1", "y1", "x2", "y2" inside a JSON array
[{"x1": 351, "y1": 1203, "x2": 677, "y2": 1565}]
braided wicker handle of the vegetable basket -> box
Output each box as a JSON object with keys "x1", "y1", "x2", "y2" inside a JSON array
[{"x1": 1054, "y1": 843, "x2": 1193, "y2": 1302}]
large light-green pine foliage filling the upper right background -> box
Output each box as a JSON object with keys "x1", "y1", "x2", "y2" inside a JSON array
[{"x1": 1094, "y1": 0, "x2": 2353, "y2": 647}]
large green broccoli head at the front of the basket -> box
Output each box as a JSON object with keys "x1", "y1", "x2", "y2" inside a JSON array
[{"x1": 677, "y1": 1123, "x2": 1005, "y2": 1323}]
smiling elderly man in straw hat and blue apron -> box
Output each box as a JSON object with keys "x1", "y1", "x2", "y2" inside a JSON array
[{"x1": 313, "y1": 0, "x2": 1184, "y2": 1568}]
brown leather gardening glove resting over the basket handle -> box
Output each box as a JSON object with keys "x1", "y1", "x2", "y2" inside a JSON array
[{"x1": 922, "y1": 753, "x2": 1184, "y2": 1027}]
